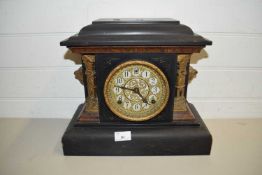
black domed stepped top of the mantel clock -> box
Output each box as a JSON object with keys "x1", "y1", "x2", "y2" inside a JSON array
[{"x1": 60, "y1": 18, "x2": 212, "y2": 47}]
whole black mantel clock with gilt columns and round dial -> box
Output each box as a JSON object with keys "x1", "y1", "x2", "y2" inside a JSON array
[{"x1": 60, "y1": 18, "x2": 212, "y2": 155}]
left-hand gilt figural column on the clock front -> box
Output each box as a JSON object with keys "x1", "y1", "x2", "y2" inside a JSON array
[{"x1": 82, "y1": 55, "x2": 98, "y2": 113}]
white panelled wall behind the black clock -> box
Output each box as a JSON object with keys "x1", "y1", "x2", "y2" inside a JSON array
[{"x1": 0, "y1": 0, "x2": 262, "y2": 118}]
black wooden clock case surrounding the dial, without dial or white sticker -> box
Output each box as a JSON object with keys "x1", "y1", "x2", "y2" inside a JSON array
[{"x1": 60, "y1": 18, "x2": 212, "y2": 156}]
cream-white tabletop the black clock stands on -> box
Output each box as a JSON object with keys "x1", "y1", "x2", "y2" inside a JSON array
[{"x1": 0, "y1": 119, "x2": 262, "y2": 175}]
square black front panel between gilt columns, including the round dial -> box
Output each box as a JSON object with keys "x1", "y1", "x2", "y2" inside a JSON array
[{"x1": 95, "y1": 53, "x2": 177, "y2": 123}]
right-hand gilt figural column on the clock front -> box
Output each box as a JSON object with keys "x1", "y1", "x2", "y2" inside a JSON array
[{"x1": 173, "y1": 55, "x2": 190, "y2": 112}]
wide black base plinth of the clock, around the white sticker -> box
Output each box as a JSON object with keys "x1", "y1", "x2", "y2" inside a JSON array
[{"x1": 62, "y1": 104, "x2": 212, "y2": 156}]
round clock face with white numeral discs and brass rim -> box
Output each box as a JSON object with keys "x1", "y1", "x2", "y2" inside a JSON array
[{"x1": 104, "y1": 61, "x2": 169, "y2": 121}]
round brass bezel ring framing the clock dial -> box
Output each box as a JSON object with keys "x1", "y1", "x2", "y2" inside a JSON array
[{"x1": 103, "y1": 60, "x2": 170, "y2": 122}]
